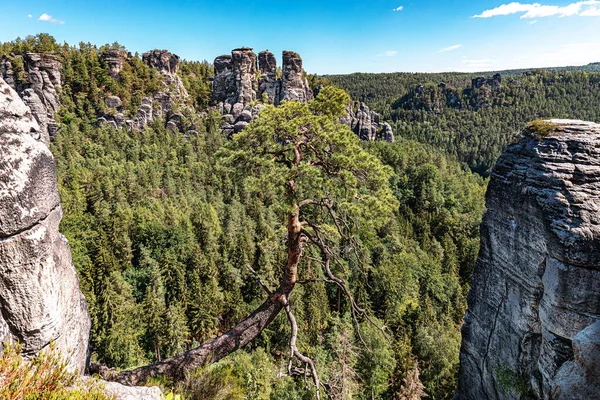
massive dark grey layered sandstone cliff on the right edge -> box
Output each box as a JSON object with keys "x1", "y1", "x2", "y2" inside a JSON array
[{"x1": 459, "y1": 120, "x2": 600, "y2": 400}]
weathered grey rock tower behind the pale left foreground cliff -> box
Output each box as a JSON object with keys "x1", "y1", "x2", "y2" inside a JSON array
[{"x1": 0, "y1": 53, "x2": 62, "y2": 144}]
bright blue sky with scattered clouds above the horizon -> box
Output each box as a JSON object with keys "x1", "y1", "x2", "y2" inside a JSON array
[{"x1": 0, "y1": 0, "x2": 600, "y2": 74}]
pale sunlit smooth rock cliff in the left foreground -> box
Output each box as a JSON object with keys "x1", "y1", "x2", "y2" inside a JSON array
[{"x1": 0, "y1": 79, "x2": 90, "y2": 372}]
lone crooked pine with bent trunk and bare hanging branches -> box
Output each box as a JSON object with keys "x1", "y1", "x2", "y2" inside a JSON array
[{"x1": 103, "y1": 87, "x2": 397, "y2": 397}]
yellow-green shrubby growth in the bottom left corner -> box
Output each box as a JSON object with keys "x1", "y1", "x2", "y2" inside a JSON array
[{"x1": 0, "y1": 343, "x2": 112, "y2": 400}]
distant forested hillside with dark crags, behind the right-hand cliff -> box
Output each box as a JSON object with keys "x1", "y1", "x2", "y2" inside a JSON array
[{"x1": 325, "y1": 64, "x2": 600, "y2": 175}]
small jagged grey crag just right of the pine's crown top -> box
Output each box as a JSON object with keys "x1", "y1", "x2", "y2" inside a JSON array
[{"x1": 340, "y1": 102, "x2": 394, "y2": 142}]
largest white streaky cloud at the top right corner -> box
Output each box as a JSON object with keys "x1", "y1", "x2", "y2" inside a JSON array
[{"x1": 471, "y1": 0, "x2": 600, "y2": 19}]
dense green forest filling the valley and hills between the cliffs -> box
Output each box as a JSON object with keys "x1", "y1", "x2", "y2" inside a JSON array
[{"x1": 0, "y1": 34, "x2": 600, "y2": 400}]
